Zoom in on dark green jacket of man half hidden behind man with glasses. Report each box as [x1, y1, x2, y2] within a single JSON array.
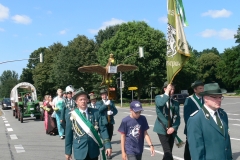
[[183, 94, 201, 135]]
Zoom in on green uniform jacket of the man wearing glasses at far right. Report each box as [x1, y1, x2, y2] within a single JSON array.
[[187, 106, 232, 160]]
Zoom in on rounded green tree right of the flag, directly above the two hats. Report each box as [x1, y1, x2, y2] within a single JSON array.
[[196, 53, 221, 84]]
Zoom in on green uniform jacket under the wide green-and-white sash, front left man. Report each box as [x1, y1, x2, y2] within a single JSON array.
[[65, 108, 111, 160]]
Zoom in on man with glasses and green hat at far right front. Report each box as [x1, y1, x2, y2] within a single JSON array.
[[187, 83, 232, 160]]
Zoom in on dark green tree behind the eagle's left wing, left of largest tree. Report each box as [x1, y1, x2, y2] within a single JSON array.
[[51, 35, 97, 91]]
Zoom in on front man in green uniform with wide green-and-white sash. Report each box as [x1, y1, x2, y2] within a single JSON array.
[[65, 89, 112, 160]]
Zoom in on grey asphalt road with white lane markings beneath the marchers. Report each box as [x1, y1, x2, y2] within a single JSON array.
[[0, 98, 240, 160]]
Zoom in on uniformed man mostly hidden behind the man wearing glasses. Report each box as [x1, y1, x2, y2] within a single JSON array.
[[183, 80, 204, 160]]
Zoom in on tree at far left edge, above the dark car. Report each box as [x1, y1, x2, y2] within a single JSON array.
[[0, 70, 18, 97]]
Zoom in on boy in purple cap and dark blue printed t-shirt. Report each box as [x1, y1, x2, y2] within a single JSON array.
[[118, 101, 155, 160]]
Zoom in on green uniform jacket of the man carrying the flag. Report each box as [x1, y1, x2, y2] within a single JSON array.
[[153, 94, 180, 136]]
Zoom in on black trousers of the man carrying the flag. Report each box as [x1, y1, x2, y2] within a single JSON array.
[[158, 134, 174, 160]]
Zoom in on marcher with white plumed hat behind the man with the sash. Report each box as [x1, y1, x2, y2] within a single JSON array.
[[61, 85, 76, 128]]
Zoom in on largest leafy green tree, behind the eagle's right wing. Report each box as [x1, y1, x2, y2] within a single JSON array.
[[97, 21, 167, 99]]
